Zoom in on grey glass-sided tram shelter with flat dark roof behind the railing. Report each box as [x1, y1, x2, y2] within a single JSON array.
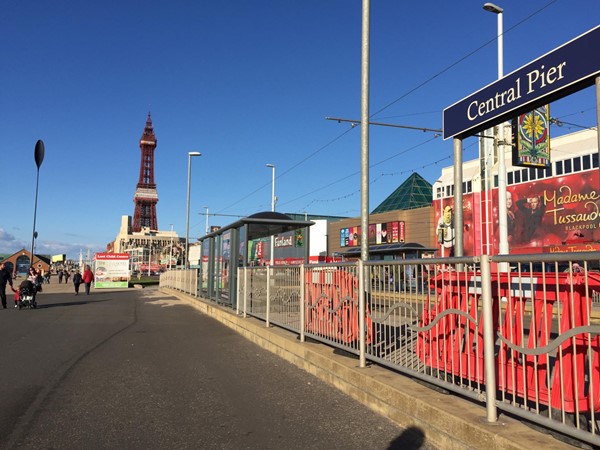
[[198, 211, 314, 308]]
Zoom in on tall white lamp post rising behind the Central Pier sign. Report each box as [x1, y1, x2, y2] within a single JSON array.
[[483, 3, 509, 272]]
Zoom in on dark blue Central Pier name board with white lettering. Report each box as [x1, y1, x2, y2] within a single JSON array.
[[443, 25, 600, 139]]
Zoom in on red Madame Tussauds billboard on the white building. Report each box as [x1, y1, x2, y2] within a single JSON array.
[[434, 170, 600, 256]]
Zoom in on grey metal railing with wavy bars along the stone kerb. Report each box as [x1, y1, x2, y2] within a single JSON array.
[[161, 252, 600, 445]]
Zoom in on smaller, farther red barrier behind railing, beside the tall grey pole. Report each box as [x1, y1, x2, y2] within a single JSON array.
[[304, 268, 373, 344]]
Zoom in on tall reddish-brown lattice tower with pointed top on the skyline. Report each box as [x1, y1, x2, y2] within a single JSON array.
[[131, 113, 158, 232]]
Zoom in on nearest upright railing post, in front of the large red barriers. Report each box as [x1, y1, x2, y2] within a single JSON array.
[[480, 255, 498, 422]]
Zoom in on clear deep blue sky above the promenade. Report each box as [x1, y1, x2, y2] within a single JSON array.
[[0, 0, 600, 258]]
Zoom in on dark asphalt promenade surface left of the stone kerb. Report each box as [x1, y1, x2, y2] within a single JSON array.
[[0, 287, 432, 450]]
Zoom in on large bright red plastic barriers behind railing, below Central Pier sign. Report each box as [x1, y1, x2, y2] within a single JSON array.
[[417, 271, 600, 412]]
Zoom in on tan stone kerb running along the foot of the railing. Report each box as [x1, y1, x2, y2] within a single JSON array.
[[162, 288, 589, 450]]
